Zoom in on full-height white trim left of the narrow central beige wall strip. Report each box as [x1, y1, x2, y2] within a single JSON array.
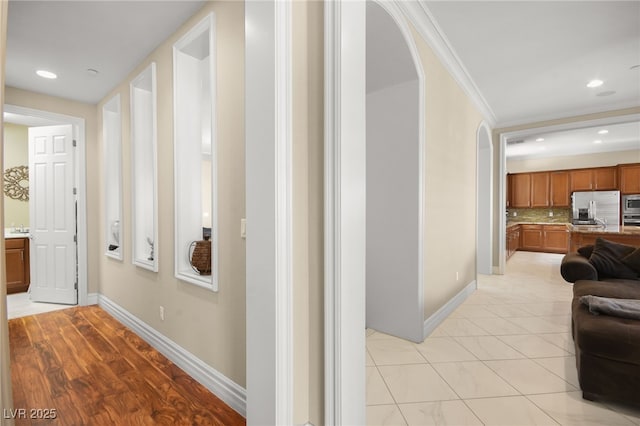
[[245, 0, 294, 425]]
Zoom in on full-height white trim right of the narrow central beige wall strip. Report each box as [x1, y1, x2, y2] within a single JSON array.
[[324, 0, 366, 426]]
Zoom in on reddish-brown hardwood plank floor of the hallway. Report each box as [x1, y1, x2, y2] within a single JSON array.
[[4, 306, 246, 426]]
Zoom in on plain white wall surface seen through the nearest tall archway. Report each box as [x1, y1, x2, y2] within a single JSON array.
[[366, 80, 423, 341]]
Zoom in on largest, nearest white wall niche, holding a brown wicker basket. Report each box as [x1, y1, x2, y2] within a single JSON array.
[[173, 14, 219, 291]]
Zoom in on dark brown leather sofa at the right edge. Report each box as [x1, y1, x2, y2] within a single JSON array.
[[560, 243, 640, 406]]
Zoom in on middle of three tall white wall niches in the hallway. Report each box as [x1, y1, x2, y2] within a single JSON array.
[[130, 62, 158, 272]]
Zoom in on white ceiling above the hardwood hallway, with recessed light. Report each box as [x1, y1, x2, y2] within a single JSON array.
[[5, 0, 203, 104]]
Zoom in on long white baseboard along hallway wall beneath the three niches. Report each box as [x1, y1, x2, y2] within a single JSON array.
[[97, 294, 247, 417]]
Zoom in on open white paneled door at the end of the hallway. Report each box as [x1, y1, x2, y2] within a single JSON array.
[[29, 125, 78, 305]]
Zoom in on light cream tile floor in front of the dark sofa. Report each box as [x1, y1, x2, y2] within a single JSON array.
[[366, 252, 640, 426]]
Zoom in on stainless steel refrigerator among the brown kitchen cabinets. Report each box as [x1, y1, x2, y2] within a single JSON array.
[[571, 191, 620, 226]]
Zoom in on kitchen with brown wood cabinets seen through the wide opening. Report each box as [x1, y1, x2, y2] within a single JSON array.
[[506, 122, 640, 259]]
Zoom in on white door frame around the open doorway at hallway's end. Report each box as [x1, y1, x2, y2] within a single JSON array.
[[4, 104, 89, 306]]
